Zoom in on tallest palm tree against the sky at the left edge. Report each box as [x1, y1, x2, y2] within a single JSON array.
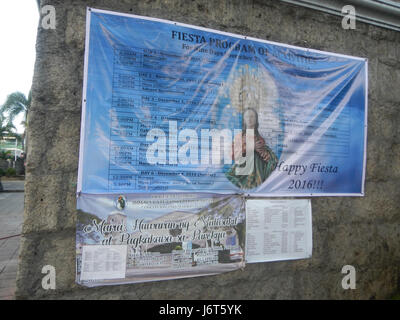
[[0, 91, 32, 151]]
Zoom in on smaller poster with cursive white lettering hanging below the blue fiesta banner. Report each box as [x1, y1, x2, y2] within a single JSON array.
[[76, 194, 246, 286]]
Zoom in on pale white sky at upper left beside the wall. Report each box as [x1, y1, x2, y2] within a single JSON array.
[[0, 0, 39, 133]]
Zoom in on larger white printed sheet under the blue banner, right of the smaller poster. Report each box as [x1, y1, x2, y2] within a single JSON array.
[[246, 199, 312, 263]]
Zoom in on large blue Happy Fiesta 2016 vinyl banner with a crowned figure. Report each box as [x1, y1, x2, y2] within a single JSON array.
[[78, 9, 367, 196]]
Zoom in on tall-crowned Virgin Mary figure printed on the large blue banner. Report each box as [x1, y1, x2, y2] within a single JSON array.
[[225, 68, 278, 189]]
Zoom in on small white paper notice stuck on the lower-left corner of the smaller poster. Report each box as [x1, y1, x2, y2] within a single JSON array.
[[81, 245, 127, 280]]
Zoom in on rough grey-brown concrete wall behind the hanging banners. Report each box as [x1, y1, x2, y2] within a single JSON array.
[[17, 0, 400, 299]]
